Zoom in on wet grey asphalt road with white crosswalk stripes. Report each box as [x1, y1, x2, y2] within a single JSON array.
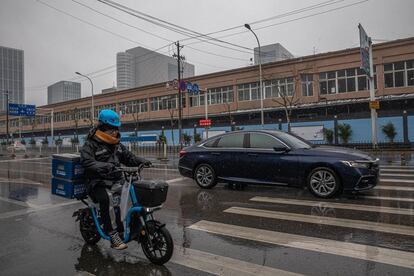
[[0, 158, 414, 275]]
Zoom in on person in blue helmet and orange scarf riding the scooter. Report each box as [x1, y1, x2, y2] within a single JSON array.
[[80, 110, 151, 250]]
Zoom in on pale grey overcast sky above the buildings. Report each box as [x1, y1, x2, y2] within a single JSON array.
[[0, 0, 414, 105]]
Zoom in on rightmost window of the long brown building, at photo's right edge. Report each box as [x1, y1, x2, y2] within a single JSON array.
[[384, 60, 414, 88]]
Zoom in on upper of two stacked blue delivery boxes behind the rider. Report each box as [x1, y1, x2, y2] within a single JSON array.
[[52, 153, 83, 179]]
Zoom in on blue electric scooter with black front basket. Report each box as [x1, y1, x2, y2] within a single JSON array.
[[73, 165, 174, 265]]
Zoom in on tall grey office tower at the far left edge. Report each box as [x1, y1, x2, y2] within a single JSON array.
[[0, 46, 24, 112]]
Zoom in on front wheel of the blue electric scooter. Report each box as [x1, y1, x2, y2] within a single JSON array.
[[141, 221, 174, 265]]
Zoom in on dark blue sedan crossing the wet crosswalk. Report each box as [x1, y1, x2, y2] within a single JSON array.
[[178, 130, 379, 198]]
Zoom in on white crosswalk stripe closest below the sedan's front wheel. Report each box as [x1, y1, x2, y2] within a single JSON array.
[[250, 196, 414, 216]]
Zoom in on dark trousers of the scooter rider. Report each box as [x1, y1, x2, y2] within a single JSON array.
[[89, 186, 124, 235]]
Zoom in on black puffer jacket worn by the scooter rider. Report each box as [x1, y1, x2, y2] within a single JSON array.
[[80, 128, 147, 191]]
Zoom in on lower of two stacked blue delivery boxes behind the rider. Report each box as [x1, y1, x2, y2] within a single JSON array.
[[52, 177, 86, 198]]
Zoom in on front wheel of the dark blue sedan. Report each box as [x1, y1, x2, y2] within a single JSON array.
[[308, 167, 341, 198]]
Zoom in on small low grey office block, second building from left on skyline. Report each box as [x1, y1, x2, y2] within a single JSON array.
[[47, 81, 81, 104]]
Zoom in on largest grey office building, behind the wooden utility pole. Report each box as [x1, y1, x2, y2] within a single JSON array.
[[116, 47, 194, 90]]
